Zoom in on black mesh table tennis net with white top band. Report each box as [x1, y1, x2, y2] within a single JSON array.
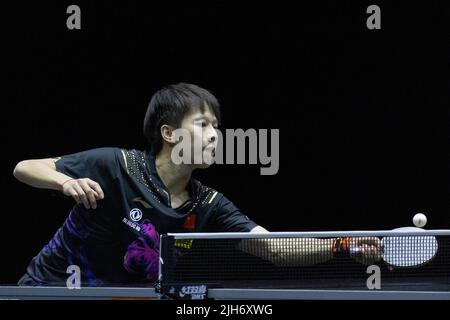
[[160, 232, 450, 291]]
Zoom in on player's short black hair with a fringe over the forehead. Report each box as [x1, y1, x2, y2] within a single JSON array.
[[144, 83, 220, 155]]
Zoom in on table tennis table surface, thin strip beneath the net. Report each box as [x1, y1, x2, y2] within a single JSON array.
[[0, 286, 450, 300]]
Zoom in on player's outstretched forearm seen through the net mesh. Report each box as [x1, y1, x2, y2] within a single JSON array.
[[239, 238, 333, 266]]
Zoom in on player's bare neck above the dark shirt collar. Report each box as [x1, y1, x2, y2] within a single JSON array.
[[155, 150, 192, 196]]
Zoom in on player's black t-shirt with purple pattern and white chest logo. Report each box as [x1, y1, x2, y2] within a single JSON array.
[[22, 148, 257, 286]]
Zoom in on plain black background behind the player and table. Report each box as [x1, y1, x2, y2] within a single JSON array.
[[0, 0, 450, 283]]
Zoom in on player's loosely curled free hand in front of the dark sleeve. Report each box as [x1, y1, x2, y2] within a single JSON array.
[[62, 178, 104, 209]]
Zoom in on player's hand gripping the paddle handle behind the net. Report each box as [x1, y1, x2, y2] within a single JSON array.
[[350, 237, 383, 265]]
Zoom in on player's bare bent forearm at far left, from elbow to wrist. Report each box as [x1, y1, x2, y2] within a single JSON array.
[[14, 159, 71, 191]]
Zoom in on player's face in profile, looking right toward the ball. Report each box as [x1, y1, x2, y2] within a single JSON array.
[[181, 105, 218, 168]]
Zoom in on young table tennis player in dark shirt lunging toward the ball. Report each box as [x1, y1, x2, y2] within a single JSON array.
[[14, 83, 379, 286]]
